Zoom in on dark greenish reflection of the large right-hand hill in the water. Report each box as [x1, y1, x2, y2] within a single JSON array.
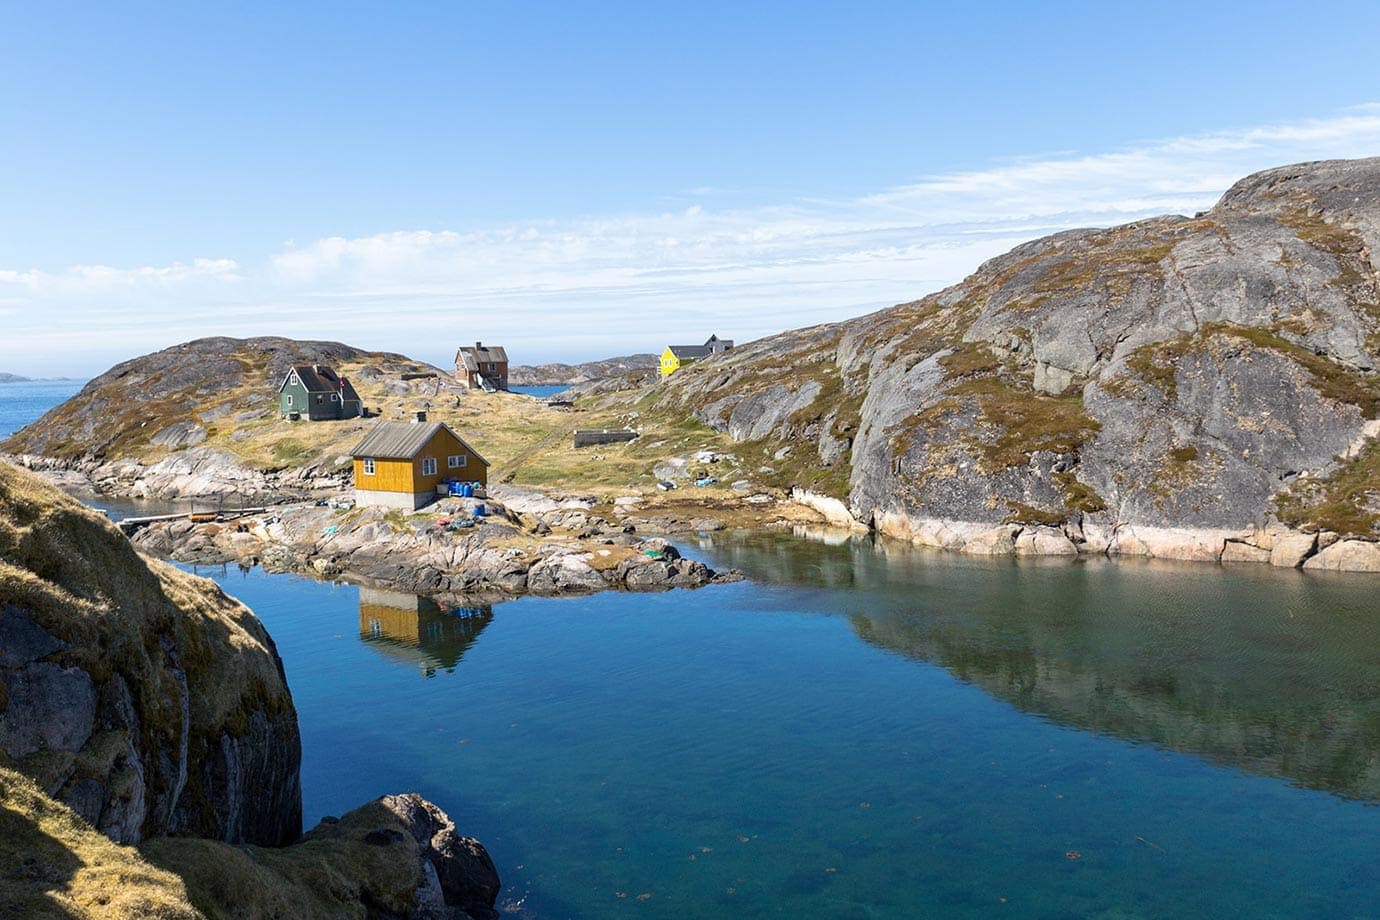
[[713, 537, 1380, 801]]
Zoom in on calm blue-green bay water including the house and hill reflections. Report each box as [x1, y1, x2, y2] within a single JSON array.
[[197, 537, 1380, 917]]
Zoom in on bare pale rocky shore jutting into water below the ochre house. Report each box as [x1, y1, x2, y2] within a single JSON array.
[[131, 488, 741, 597]]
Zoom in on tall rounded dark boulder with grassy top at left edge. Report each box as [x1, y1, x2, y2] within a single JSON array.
[[0, 463, 301, 846]]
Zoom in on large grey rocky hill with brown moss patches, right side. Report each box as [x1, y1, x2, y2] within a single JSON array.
[[642, 159, 1380, 564]]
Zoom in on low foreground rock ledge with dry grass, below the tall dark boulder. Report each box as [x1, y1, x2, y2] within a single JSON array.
[[0, 767, 500, 920]]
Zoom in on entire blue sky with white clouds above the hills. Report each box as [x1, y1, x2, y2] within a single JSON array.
[[0, 1, 1380, 375]]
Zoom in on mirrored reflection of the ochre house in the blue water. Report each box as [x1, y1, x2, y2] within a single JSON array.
[[359, 588, 494, 677]]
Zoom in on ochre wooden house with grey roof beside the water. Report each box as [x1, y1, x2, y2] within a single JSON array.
[[351, 422, 489, 510]]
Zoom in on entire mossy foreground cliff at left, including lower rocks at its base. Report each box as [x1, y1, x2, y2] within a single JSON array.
[[0, 462, 498, 920]]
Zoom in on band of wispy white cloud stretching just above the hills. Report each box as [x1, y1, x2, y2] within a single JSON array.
[[0, 105, 1380, 372]]
